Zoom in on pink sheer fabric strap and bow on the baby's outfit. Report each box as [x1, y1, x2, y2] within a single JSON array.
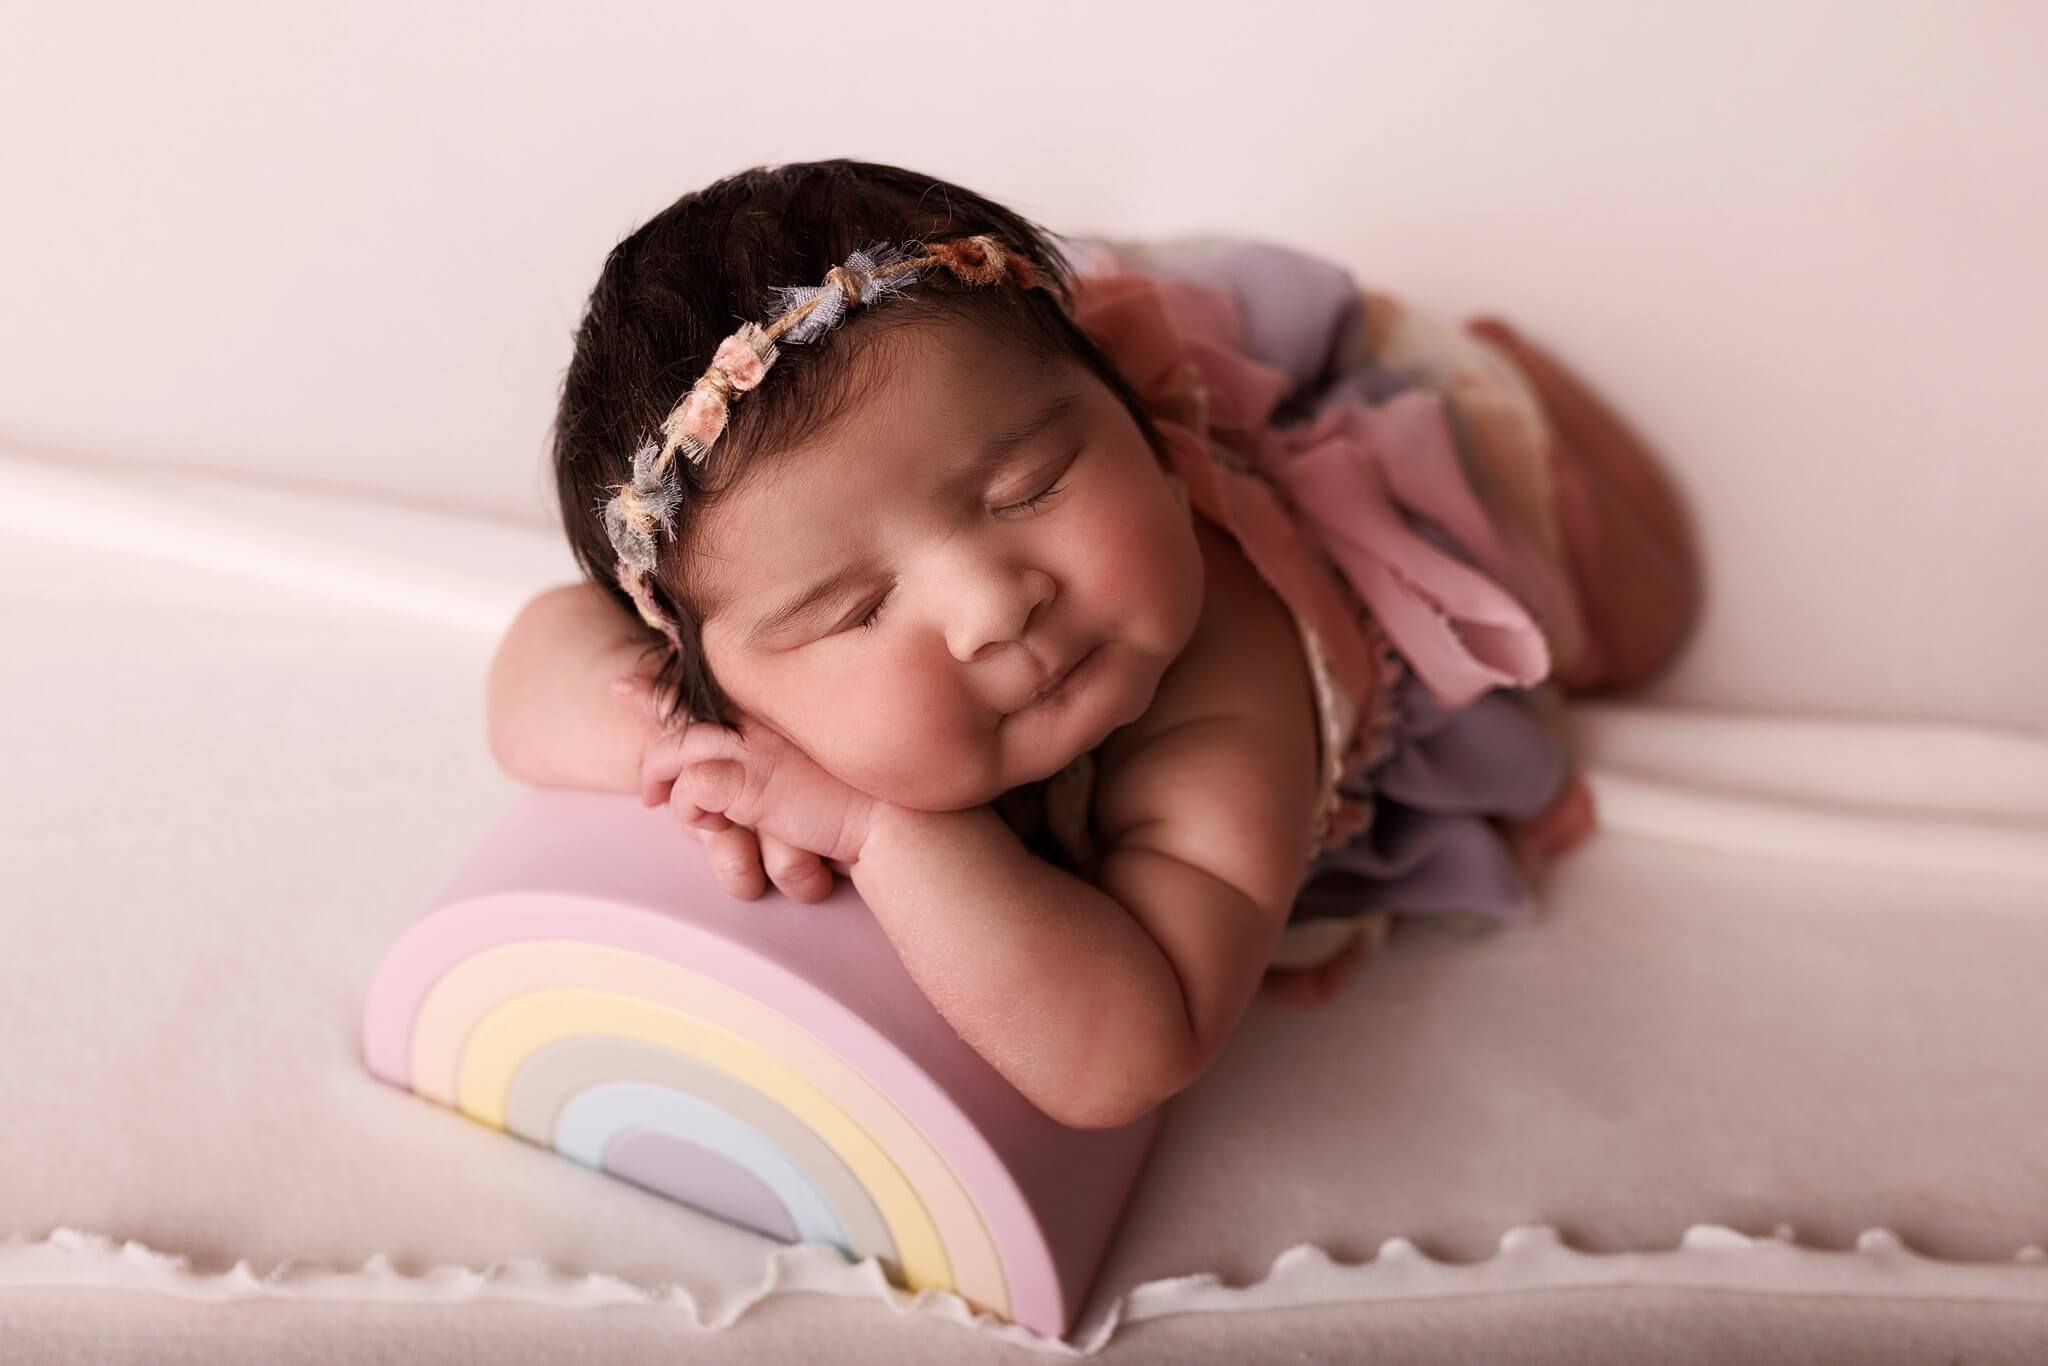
[[1075, 270, 1571, 709]]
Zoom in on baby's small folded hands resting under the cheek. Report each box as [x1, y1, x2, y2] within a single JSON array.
[[614, 674, 872, 901]]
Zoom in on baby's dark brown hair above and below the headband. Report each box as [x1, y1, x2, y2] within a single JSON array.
[[553, 160, 1161, 725]]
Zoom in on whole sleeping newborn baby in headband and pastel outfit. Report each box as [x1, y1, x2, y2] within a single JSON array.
[[489, 162, 1696, 1126]]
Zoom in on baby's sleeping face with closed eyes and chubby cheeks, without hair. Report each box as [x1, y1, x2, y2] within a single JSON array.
[[694, 319, 1202, 811]]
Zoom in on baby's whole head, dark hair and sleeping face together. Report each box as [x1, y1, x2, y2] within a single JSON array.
[[555, 162, 1202, 811]]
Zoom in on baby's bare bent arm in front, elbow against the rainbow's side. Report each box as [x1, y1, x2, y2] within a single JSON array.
[[852, 518, 1317, 1128]]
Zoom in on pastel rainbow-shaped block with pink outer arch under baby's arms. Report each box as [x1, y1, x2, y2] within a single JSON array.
[[362, 788, 1159, 1335]]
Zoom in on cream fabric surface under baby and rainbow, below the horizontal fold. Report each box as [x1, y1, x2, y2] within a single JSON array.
[[0, 457, 2048, 1360]]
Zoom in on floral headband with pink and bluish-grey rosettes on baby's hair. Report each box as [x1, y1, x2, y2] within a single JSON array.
[[604, 233, 1040, 651]]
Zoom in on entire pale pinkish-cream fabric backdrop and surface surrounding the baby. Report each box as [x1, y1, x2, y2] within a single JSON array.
[[0, 0, 2048, 1366]]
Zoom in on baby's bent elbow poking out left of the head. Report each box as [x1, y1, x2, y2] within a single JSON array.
[[485, 584, 657, 793]]
